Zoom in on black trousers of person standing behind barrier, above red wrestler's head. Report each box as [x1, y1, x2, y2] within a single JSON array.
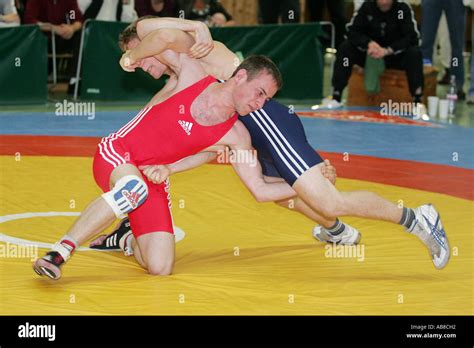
[[258, 0, 301, 24]]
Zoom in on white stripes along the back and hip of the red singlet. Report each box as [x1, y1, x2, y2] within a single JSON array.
[[99, 106, 152, 168]]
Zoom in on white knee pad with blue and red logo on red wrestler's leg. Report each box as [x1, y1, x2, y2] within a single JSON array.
[[102, 175, 148, 219]]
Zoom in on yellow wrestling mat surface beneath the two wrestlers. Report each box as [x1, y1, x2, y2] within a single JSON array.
[[0, 156, 474, 315]]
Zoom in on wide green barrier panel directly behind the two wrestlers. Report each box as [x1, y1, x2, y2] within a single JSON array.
[[80, 21, 323, 101]]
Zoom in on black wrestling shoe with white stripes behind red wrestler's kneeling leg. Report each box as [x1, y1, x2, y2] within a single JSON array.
[[89, 219, 133, 256]]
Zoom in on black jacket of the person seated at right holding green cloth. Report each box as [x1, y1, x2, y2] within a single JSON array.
[[346, 0, 420, 54]]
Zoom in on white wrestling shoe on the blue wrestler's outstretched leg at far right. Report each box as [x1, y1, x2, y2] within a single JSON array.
[[407, 204, 450, 269]]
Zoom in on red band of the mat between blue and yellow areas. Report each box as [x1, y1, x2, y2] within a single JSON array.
[[0, 135, 474, 200]]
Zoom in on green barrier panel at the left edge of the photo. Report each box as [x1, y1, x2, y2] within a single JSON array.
[[0, 25, 48, 105]]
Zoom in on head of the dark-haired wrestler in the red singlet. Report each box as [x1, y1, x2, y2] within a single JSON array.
[[232, 56, 283, 115]]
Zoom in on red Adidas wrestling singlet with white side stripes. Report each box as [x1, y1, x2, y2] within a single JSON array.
[[93, 76, 237, 237]]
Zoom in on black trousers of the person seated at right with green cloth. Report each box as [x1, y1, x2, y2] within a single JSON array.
[[332, 40, 424, 96]]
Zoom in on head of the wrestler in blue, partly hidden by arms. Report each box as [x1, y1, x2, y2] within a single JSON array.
[[119, 16, 168, 79]]
